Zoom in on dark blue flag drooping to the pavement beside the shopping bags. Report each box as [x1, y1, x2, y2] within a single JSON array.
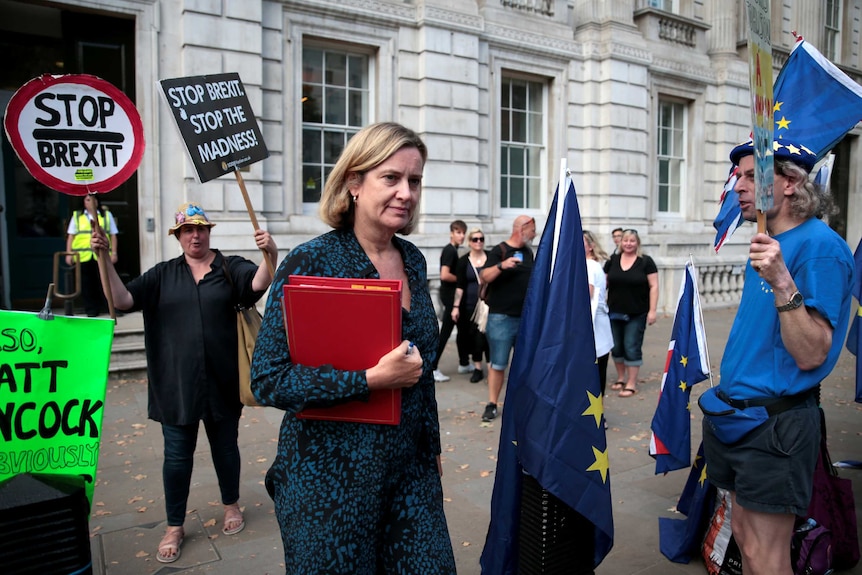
[[658, 443, 716, 563]]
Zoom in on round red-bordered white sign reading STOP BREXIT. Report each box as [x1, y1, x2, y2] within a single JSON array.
[[4, 74, 144, 196]]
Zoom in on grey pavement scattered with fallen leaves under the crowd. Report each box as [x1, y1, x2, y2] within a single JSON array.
[[90, 309, 862, 575]]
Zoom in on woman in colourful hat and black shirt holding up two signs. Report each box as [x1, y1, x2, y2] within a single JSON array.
[[91, 204, 278, 563]]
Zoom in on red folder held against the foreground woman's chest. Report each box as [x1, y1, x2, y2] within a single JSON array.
[[283, 276, 401, 425]]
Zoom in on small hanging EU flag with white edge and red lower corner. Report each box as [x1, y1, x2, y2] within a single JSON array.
[[650, 262, 709, 474]]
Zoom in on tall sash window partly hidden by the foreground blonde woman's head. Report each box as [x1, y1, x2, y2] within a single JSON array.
[[302, 46, 369, 203]]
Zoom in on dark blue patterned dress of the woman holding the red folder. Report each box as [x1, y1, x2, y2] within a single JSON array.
[[251, 230, 455, 575]]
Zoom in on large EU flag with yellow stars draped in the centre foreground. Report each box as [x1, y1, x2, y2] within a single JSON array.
[[481, 174, 614, 575]]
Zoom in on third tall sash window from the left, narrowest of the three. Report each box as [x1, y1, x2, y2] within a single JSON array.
[[656, 100, 686, 214]]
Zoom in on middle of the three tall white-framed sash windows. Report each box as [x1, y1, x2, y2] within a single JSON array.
[[500, 77, 545, 209]]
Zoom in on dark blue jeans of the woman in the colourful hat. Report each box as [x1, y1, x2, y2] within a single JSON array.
[[162, 418, 240, 527]]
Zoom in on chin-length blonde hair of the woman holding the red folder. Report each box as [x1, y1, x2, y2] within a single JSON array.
[[320, 122, 428, 235]]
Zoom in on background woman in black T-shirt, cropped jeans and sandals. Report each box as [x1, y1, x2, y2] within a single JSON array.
[[605, 230, 658, 397]]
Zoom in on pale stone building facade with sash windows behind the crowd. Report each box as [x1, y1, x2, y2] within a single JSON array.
[[0, 0, 862, 313]]
